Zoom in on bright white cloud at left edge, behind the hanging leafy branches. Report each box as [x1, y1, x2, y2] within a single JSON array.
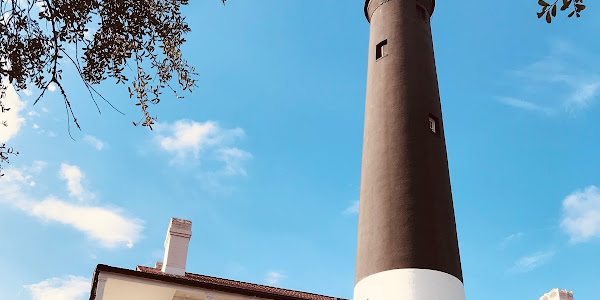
[[0, 80, 25, 143]]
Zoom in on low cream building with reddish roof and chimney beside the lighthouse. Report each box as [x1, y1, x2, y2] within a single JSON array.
[[90, 218, 346, 300]]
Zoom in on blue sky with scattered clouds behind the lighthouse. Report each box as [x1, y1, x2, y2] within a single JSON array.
[[0, 0, 600, 300]]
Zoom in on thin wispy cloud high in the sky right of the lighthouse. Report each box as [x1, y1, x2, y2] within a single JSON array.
[[500, 41, 600, 115]]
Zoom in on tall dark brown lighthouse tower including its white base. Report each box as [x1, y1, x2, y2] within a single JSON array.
[[354, 0, 465, 300]]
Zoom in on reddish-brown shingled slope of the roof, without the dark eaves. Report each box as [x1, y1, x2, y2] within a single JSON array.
[[137, 266, 347, 300]]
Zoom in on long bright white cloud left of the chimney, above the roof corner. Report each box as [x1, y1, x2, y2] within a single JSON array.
[[0, 164, 143, 248]]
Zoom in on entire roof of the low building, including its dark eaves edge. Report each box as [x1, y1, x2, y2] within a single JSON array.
[[90, 265, 347, 300]]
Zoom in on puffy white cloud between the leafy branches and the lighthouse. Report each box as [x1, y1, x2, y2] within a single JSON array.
[[156, 120, 252, 176]]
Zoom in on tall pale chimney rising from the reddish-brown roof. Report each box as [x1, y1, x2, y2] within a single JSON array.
[[161, 218, 192, 276]]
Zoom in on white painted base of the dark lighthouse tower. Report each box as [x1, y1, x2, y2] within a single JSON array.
[[353, 269, 465, 300]]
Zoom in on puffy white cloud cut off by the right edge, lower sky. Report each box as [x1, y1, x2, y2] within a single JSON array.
[[560, 185, 600, 243]]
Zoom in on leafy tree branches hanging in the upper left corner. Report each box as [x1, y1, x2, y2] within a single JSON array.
[[0, 0, 225, 178]]
